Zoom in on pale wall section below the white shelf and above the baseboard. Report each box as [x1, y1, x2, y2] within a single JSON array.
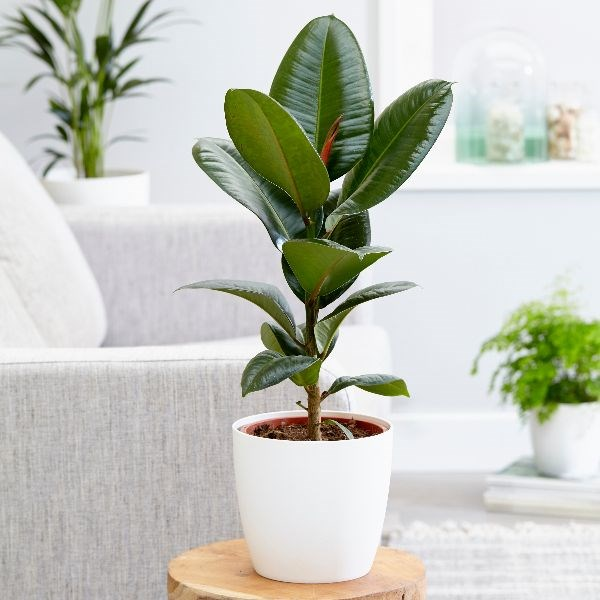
[[371, 185, 600, 412]]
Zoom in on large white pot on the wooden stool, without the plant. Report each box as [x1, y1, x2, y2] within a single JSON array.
[[233, 411, 393, 583]]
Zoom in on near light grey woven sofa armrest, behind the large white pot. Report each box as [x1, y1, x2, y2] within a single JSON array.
[[0, 340, 348, 600]]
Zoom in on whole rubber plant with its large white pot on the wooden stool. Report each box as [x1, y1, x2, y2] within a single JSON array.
[[182, 16, 452, 583]]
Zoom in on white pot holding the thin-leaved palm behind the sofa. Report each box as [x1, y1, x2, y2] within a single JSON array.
[[42, 169, 150, 206]]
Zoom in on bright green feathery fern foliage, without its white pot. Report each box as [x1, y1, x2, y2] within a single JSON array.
[[472, 289, 600, 422]]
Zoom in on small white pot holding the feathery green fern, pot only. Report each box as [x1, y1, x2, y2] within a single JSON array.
[[530, 402, 600, 479]]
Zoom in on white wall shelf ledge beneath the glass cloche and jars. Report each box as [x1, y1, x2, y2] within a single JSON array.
[[401, 157, 600, 192]]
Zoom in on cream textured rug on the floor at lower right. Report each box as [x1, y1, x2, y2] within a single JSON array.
[[388, 522, 600, 600]]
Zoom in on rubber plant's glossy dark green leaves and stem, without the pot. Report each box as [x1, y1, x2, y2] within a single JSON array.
[[180, 16, 452, 440]]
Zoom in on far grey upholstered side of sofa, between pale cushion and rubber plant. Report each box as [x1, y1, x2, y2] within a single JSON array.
[[63, 201, 364, 346]]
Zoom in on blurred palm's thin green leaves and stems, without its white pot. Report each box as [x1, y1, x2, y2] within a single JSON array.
[[0, 0, 172, 177]]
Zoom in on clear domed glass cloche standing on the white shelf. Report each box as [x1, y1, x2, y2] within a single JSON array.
[[455, 30, 547, 163]]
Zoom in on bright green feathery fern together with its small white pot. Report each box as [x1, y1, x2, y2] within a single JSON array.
[[473, 289, 600, 479]]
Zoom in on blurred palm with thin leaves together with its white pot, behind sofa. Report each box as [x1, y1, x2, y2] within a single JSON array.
[[0, 0, 170, 205]]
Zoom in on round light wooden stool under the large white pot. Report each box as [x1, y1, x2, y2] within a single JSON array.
[[167, 540, 425, 600]]
